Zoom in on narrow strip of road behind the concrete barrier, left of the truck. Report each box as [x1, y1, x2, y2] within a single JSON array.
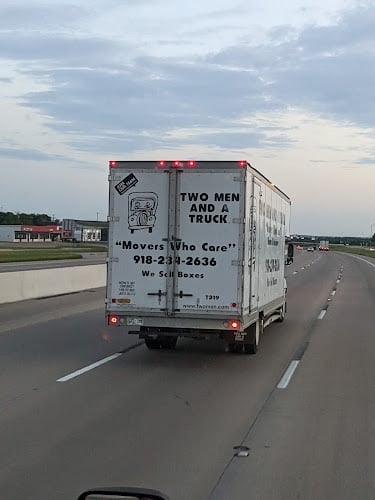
[[0, 252, 107, 273]]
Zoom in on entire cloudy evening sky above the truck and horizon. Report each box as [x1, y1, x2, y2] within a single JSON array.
[[0, 0, 375, 236]]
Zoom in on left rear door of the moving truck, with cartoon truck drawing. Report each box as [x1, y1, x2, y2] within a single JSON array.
[[107, 166, 169, 312]]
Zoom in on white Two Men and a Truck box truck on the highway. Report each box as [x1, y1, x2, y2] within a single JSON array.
[[106, 161, 290, 353]]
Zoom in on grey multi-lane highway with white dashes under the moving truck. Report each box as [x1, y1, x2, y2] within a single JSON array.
[[0, 251, 375, 500]]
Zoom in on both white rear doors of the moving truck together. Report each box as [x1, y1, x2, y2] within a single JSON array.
[[107, 162, 245, 316]]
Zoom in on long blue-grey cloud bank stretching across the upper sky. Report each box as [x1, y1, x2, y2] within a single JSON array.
[[0, 2, 375, 152]]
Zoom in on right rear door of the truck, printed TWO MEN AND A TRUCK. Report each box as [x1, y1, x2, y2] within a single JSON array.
[[172, 170, 244, 315]]
